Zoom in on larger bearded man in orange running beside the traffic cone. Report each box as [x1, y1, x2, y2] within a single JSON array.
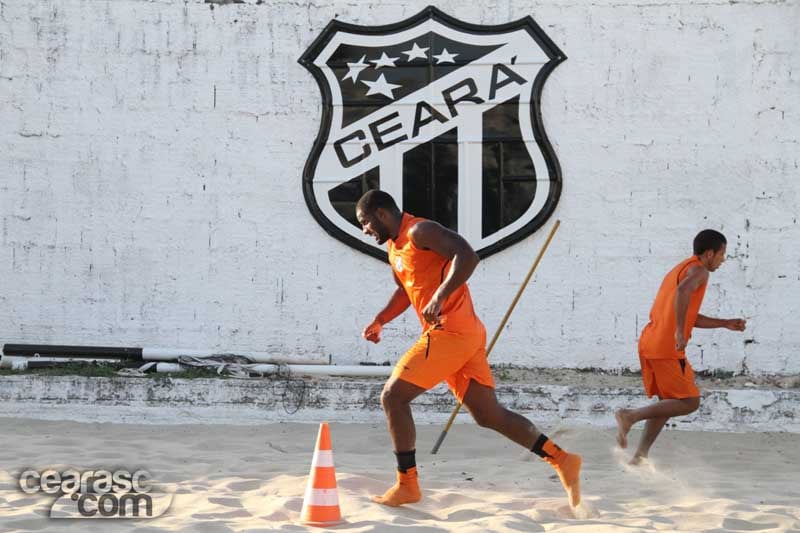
[[356, 190, 581, 507]]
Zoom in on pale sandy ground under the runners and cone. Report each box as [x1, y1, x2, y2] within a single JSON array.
[[0, 419, 800, 533]]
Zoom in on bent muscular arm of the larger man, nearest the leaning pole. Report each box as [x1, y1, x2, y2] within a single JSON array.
[[409, 221, 480, 324]]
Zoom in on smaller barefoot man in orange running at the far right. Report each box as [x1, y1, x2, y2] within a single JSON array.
[[615, 229, 745, 464]]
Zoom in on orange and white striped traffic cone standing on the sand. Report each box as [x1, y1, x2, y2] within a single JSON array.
[[300, 422, 342, 527]]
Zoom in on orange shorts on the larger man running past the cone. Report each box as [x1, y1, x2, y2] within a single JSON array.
[[392, 328, 494, 402]]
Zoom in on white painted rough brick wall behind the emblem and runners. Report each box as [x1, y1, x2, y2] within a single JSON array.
[[0, 0, 800, 373]]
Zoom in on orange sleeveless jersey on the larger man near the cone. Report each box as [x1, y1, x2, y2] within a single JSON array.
[[388, 213, 483, 332]]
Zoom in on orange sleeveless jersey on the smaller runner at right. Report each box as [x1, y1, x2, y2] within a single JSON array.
[[639, 256, 708, 359]]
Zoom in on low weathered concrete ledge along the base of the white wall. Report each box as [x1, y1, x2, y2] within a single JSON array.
[[0, 375, 800, 433]]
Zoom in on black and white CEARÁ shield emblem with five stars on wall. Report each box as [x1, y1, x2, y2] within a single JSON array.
[[300, 7, 566, 259]]
